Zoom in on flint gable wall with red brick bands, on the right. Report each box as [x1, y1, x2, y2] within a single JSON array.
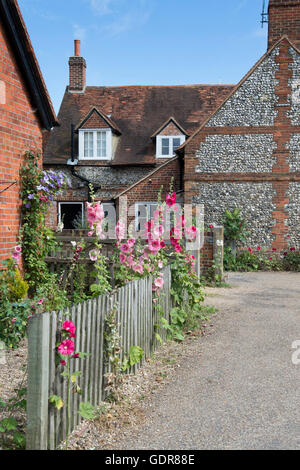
[[185, 38, 300, 250]]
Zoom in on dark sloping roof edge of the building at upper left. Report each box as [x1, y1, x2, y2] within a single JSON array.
[[0, 0, 59, 130]]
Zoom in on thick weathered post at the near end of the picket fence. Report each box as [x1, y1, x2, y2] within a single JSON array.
[[26, 313, 50, 450]]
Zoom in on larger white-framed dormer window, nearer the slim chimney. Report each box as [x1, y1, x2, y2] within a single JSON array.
[[79, 129, 112, 160]]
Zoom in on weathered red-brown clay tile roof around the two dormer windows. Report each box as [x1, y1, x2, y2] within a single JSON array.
[[44, 85, 233, 165]]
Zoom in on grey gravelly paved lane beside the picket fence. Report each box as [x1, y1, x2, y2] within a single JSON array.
[[110, 273, 300, 450]]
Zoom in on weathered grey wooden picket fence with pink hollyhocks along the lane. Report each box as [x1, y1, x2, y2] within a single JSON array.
[[26, 266, 171, 450]]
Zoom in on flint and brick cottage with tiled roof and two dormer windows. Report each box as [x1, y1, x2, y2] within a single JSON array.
[[44, 0, 300, 250]]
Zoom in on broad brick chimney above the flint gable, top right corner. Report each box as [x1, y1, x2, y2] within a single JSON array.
[[268, 0, 300, 48]]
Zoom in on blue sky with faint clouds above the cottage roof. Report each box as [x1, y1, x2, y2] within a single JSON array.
[[19, 0, 267, 112]]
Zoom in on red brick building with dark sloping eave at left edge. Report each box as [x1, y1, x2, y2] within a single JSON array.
[[0, 0, 58, 260]]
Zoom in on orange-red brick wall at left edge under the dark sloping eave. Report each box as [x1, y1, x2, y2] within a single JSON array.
[[0, 20, 42, 260]]
